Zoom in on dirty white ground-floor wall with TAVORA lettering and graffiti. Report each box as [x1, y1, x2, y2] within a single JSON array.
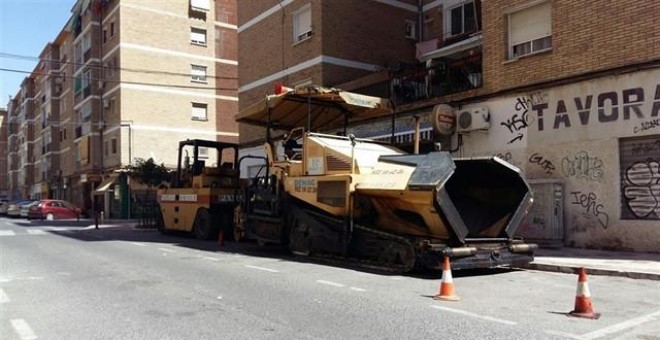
[[461, 70, 660, 252]]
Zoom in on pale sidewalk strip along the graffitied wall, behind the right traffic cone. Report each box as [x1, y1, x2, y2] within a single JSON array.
[[523, 248, 660, 281]]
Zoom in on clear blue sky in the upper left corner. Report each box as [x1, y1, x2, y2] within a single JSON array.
[[0, 0, 75, 108]]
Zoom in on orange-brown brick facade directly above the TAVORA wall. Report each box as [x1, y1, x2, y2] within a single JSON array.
[[483, 0, 660, 92]]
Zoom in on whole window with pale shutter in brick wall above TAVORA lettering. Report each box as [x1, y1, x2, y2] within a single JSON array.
[[508, 2, 552, 59]]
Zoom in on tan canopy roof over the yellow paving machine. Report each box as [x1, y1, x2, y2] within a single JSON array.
[[236, 86, 391, 132]]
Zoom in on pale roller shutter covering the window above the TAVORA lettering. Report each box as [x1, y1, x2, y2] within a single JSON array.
[[509, 2, 552, 46]]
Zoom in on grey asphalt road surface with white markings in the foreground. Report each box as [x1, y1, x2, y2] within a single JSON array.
[[0, 217, 660, 340]]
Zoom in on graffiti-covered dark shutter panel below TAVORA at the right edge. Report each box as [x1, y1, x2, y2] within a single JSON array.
[[619, 135, 660, 220]]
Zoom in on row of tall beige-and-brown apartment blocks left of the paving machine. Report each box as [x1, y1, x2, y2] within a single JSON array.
[[5, 0, 238, 217]]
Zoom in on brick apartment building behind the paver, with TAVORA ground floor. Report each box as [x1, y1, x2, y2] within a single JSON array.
[[238, 0, 660, 251]]
